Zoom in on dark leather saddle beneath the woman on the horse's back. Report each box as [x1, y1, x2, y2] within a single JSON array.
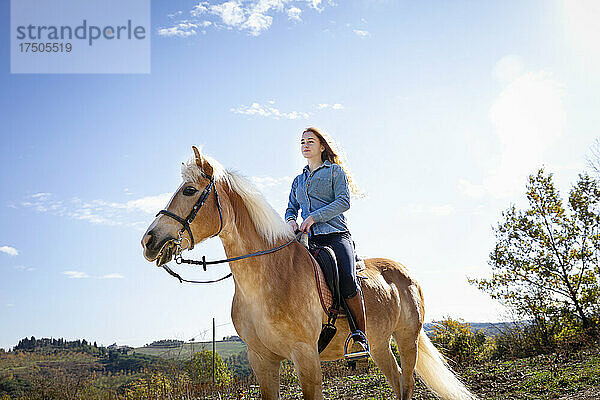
[[307, 239, 366, 353]]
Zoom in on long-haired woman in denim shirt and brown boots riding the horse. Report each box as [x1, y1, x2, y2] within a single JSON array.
[[285, 128, 368, 352]]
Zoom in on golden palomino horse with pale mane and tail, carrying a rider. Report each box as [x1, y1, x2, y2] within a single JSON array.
[[142, 147, 476, 400]]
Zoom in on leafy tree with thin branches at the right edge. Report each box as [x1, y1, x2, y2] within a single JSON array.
[[470, 168, 600, 342]]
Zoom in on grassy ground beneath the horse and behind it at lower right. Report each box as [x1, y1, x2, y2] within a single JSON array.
[[215, 349, 600, 400]]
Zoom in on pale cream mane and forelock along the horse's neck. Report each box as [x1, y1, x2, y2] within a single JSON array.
[[181, 155, 294, 245]]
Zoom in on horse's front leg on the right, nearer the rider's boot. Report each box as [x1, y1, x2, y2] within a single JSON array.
[[290, 343, 323, 400]]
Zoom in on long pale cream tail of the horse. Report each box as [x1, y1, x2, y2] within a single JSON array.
[[416, 330, 477, 400]]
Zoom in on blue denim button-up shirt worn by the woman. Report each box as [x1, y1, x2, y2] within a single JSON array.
[[285, 160, 350, 235]]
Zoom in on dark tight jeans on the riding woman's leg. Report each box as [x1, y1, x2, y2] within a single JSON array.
[[308, 232, 360, 299]]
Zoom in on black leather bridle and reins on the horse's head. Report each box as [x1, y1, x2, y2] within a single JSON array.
[[156, 176, 303, 283]]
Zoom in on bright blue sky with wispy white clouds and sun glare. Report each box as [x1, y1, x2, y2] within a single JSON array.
[[0, 0, 600, 349]]
